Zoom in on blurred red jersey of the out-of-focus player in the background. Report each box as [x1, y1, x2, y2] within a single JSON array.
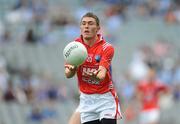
[[138, 81, 167, 110]]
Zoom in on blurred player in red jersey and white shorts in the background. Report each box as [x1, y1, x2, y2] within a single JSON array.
[[137, 68, 168, 124]]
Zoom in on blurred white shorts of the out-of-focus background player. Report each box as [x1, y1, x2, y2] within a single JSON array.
[[140, 109, 160, 124]]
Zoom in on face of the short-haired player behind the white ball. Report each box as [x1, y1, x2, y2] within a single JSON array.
[[80, 17, 100, 40]]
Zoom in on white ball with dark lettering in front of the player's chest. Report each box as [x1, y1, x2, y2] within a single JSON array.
[[63, 41, 88, 66]]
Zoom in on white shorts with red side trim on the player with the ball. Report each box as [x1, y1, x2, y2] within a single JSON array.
[[76, 92, 121, 123]]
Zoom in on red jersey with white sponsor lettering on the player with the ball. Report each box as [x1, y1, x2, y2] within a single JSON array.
[[75, 35, 114, 94]]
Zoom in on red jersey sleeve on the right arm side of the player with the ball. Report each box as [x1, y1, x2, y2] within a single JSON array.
[[99, 45, 114, 69]]
